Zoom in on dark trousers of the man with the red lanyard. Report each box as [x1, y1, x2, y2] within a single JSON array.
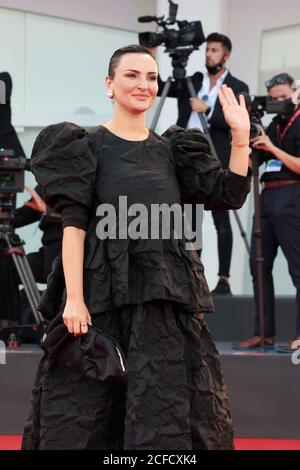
[[250, 183, 300, 337]]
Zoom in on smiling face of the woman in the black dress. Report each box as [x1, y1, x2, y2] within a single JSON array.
[[106, 53, 158, 114]]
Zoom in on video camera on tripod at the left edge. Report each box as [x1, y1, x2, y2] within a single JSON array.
[[0, 149, 43, 344]]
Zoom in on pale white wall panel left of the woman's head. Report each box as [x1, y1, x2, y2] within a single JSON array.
[[0, 8, 137, 128]]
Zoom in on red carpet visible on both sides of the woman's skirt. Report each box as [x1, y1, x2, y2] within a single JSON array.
[[0, 436, 300, 450]]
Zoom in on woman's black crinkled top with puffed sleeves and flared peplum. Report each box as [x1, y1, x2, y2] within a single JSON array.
[[31, 123, 250, 314]]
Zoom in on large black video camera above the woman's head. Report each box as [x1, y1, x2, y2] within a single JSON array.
[[138, 0, 205, 53]]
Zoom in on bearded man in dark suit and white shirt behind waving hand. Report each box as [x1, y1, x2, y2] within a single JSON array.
[[151, 33, 249, 295]]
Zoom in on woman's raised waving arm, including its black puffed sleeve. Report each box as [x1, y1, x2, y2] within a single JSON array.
[[163, 85, 250, 210]]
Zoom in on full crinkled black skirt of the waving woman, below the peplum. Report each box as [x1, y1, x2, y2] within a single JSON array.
[[22, 301, 233, 450]]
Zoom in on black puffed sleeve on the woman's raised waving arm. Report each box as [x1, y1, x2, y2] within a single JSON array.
[[163, 126, 251, 210]]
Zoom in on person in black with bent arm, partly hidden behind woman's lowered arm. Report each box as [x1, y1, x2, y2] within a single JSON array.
[[14, 185, 62, 284]]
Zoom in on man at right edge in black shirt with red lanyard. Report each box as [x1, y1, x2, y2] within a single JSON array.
[[233, 73, 300, 352]]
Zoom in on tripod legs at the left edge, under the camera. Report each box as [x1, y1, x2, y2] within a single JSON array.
[[0, 223, 43, 341]]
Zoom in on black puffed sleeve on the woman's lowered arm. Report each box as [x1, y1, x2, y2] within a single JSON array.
[[31, 122, 97, 229]]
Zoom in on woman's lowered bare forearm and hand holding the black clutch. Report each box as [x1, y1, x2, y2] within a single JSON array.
[[62, 226, 91, 336]]
